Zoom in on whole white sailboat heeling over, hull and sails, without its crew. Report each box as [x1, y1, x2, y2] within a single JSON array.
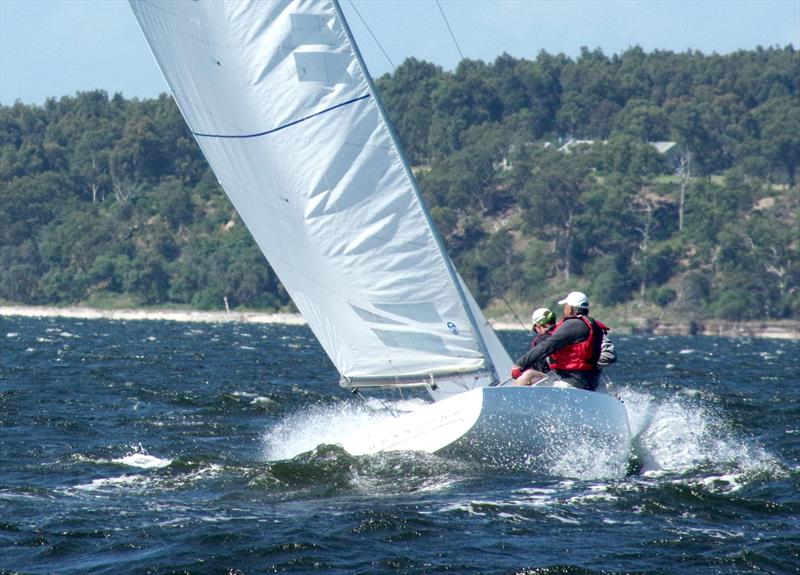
[[130, 0, 630, 474]]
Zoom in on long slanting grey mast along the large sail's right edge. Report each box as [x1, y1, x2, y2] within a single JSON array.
[[331, 0, 500, 388]]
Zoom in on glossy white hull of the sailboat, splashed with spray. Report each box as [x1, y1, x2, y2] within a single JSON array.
[[343, 386, 631, 471]]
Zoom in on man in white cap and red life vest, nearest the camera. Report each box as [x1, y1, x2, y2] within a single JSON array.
[[511, 292, 616, 391]]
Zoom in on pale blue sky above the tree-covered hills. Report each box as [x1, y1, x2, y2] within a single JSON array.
[[0, 0, 800, 105]]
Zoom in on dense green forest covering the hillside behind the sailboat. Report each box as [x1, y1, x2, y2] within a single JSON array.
[[0, 47, 800, 319]]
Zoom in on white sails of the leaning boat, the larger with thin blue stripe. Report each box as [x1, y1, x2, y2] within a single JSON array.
[[130, 0, 510, 385]]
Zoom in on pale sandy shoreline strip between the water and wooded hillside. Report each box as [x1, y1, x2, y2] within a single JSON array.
[[0, 305, 800, 340]]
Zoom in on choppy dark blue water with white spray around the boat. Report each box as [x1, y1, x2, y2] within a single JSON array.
[[0, 318, 800, 575]]
